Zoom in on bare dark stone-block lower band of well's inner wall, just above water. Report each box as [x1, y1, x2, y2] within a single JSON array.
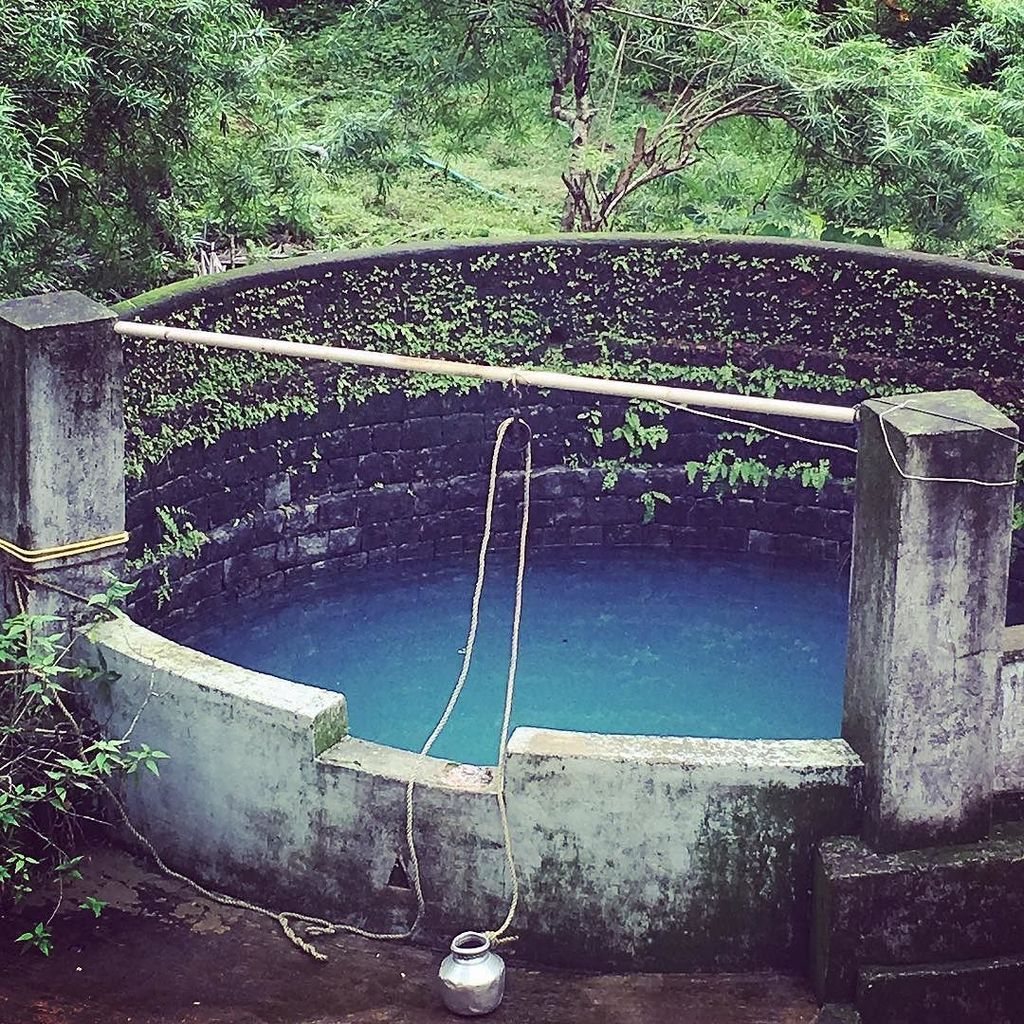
[[128, 387, 853, 627]]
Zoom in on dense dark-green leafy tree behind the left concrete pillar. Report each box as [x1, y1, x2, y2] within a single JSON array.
[[0, 0, 303, 295]]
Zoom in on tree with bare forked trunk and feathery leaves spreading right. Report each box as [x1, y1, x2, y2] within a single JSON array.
[[403, 0, 1016, 245]]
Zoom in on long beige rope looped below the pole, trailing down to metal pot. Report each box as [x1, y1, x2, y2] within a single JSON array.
[[15, 416, 534, 962]]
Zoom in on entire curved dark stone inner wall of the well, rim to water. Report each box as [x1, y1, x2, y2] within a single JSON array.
[[120, 236, 1024, 621]]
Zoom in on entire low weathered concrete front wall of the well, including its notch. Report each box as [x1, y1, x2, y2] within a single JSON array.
[[81, 621, 861, 970]]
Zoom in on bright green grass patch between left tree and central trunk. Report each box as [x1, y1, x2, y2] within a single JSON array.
[[249, 10, 566, 249]]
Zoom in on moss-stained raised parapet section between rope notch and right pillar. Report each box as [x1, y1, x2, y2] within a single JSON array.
[[507, 728, 861, 970]]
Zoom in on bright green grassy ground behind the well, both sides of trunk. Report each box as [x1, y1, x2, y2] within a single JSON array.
[[243, 6, 937, 256]]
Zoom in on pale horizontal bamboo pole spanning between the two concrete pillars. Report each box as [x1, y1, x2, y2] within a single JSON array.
[[114, 321, 857, 423]]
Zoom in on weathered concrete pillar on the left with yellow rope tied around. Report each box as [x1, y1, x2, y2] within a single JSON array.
[[0, 292, 125, 614]]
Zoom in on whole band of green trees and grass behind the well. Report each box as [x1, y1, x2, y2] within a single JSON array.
[[6, 0, 1024, 295]]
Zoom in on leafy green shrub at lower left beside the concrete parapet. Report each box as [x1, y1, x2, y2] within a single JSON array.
[[0, 581, 167, 954]]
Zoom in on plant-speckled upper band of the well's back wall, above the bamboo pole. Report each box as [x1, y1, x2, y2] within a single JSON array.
[[119, 234, 1024, 382]]
